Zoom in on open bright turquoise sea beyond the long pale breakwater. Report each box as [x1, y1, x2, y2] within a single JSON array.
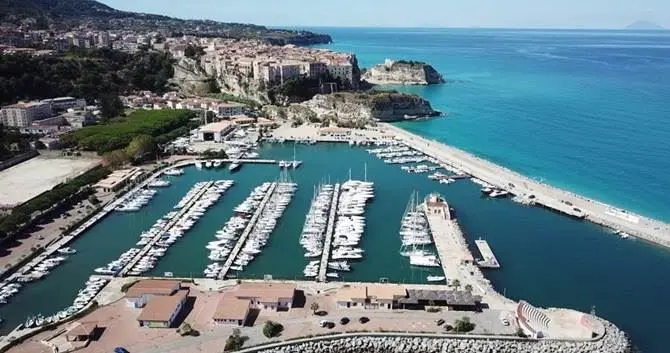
[[315, 28, 670, 221]]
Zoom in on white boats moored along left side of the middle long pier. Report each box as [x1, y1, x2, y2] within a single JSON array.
[[204, 182, 272, 278]]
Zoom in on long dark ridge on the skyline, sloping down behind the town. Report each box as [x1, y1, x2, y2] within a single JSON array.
[[0, 0, 332, 45]]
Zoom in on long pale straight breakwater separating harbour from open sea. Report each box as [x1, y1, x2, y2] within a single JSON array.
[[380, 123, 670, 248]]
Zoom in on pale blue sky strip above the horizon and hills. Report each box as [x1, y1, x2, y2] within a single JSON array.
[[102, 0, 670, 28]]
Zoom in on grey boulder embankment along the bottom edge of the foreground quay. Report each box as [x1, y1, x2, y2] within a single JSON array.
[[245, 320, 631, 353]]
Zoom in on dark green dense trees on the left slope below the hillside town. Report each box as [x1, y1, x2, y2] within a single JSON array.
[[0, 49, 173, 104]]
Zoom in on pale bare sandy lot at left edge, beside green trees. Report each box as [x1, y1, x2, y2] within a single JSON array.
[[0, 156, 100, 207]]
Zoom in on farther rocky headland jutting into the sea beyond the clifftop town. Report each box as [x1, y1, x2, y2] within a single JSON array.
[[363, 59, 445, 85]]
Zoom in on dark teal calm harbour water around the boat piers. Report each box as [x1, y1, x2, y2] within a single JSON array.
[[0, 143, 670, 353]]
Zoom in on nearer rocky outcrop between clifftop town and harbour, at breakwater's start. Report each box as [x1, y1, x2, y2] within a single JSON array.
[[264, 91, 441, 127]]
